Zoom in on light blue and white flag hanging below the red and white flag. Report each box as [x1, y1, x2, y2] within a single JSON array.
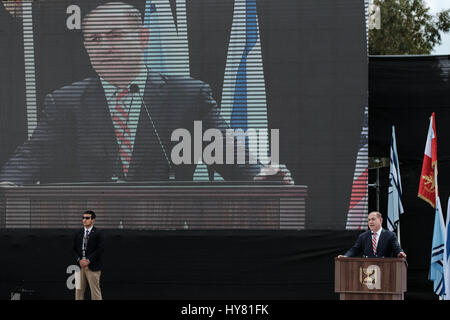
[[429, 196, 445, 297]]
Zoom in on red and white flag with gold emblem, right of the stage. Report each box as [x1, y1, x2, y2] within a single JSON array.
[[417, 112, 439, 208]]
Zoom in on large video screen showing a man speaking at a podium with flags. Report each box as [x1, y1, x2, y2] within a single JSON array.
[[0, 0, 368, 230]]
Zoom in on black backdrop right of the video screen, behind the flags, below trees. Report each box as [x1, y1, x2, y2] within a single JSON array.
[[369, 56, 450, 284]]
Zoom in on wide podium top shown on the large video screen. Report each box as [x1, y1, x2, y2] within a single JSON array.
[[0, 183, 307, 230]]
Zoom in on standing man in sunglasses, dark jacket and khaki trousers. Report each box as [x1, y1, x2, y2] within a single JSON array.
[[73, 210, 104, 300]]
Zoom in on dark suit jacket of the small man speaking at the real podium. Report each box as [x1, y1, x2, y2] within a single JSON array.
[[345, 229, 403, 258]]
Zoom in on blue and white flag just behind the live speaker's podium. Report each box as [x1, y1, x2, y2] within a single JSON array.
[[387, 126, 403, 243]]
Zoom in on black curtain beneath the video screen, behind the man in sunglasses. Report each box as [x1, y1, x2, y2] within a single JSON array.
[[0, 230, 435, 300]]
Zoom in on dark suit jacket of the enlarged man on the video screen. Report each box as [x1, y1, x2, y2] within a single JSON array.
[[0, 72, 260, 185]]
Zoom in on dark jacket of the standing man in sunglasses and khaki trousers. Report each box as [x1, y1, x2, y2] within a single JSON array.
[[72, 227, 105, 271]]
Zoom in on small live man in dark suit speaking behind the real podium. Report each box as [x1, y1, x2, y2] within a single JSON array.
[[338, 211, 406, 259]]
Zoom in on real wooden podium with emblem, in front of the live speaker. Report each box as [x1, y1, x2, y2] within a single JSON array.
[[334, 258, 406, 300]]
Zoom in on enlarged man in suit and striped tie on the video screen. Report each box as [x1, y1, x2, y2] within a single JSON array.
[[0, 2, 293, 185]]
